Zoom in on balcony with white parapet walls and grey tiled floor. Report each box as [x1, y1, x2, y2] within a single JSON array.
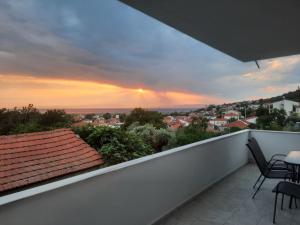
[[0, 130, 300, 225]]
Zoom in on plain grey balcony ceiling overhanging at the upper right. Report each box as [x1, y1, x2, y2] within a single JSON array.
[[121, 0, 300, 62]]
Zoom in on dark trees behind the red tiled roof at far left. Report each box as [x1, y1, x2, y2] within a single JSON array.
[[0, 104, 73, 135]]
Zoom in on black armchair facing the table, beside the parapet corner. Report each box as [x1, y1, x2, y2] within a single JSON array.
[[246, 138, 292, 199]]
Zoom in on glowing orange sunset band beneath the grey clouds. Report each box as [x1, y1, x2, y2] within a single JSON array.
[[0, 75, 224, 108]]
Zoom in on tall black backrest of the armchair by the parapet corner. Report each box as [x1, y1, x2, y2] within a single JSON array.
[[246, 138, 268, 174]]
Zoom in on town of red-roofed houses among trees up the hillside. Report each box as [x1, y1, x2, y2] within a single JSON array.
[[72, 96, 300, 133]]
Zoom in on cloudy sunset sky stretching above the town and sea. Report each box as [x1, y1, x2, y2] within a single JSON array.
[[0, 0, 300, 108]]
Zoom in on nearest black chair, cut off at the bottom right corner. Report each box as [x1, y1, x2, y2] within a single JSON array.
[[273, 181, 300, 223]]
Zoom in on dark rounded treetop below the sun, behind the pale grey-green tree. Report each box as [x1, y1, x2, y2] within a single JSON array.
[[124, 108, 166, 128]]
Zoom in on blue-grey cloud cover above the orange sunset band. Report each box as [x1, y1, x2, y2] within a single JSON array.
[[0, 0, 300, 107]]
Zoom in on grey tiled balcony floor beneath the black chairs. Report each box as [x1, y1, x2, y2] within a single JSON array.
[[159, 164, 300, 225]]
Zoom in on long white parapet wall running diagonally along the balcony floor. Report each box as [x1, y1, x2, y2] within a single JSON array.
[[0, 130, 250, 225]]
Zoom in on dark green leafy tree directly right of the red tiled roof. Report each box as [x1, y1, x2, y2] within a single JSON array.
[[74, 126, 154, 165]]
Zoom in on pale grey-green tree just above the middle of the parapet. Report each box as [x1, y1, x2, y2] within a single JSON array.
[[128, 124, 175, 152]]
